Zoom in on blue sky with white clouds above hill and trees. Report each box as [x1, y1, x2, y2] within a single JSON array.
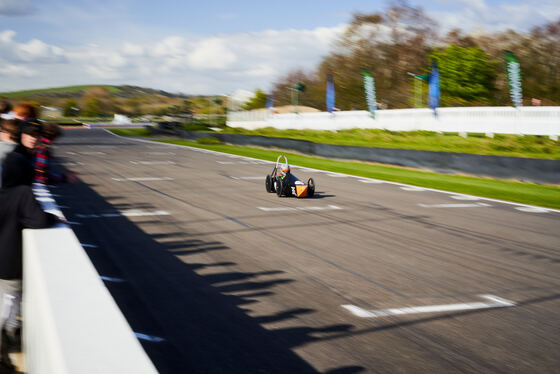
[[0, 0, 560, 95]]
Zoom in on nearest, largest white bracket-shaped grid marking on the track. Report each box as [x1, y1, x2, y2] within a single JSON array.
[[342, 295, 516, 318]]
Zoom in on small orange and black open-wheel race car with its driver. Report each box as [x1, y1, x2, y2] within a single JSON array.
[[265, 155, 315, 197]]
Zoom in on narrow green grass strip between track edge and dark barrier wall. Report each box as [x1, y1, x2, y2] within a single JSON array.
[[151, 137, 560, 209]]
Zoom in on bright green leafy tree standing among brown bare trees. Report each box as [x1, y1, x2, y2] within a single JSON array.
[[430, 44, 498, 106]]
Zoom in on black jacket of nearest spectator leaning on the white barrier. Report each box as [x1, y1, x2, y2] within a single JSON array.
[[0, 186, 56, 279]]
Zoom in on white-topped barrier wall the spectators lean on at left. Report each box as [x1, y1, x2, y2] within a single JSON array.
[[23, 185, 157, 374]]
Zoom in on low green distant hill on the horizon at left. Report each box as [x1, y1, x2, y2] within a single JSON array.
[[0, 85, 191, 100]]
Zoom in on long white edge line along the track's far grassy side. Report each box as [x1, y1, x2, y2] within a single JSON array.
[[103, 129, 560, 213]]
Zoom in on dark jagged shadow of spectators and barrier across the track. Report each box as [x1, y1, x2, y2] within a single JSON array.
[[53, 179, 364, 374]]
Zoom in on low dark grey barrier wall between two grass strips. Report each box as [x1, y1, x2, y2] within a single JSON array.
[[180, 131, 560, 184]]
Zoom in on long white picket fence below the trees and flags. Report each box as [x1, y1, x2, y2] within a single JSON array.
[[227, 106, 560, 140]]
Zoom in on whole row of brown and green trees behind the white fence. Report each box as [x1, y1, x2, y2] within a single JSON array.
[[252, 1, 560, 110]]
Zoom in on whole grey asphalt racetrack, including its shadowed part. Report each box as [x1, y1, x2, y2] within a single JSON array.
[[53, 130, 560, 374]]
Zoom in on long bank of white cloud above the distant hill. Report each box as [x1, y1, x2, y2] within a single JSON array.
[[0, 26, 343, 94]]
